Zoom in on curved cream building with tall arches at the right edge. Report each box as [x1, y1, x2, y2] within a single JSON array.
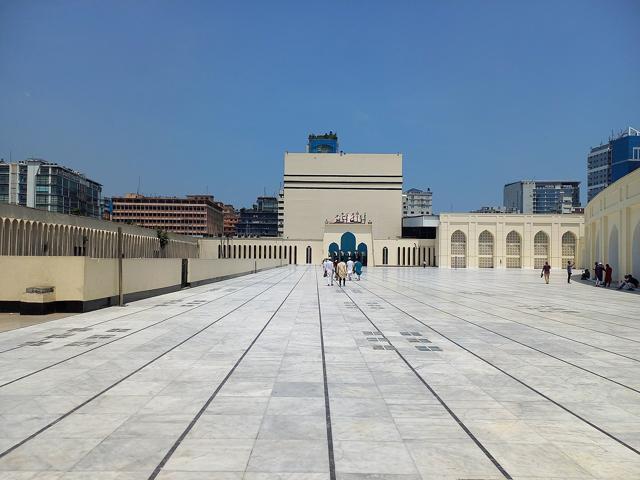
[[584, 169, 640, 280]]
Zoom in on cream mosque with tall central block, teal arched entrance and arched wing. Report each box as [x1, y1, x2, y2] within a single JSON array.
[[201, 132, 584, 268]]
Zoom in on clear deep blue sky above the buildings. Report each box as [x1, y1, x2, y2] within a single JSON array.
[[0, 0, 640, 211]]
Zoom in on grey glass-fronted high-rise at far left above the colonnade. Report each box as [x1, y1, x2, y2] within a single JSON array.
[[0, 158, 102, 218]]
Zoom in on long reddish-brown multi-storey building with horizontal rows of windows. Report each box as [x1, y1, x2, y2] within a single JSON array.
[[111, 193, 223, 237]]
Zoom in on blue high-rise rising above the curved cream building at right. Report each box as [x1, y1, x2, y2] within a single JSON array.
[[587, 127, 640, 202]]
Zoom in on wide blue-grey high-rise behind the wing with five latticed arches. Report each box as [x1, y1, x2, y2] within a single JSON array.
[[503, 180, 580, 213]]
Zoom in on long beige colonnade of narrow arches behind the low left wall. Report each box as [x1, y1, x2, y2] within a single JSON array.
[[0, 218, 198, 258]]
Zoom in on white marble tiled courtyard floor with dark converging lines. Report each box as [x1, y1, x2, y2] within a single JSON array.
[[0, 267, 640, 480]]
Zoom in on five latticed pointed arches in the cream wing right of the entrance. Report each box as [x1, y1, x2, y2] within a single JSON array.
[[450, 230, 578, 268]]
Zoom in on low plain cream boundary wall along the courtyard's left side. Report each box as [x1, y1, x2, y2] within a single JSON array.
[[0, 256, 282, 313]]
